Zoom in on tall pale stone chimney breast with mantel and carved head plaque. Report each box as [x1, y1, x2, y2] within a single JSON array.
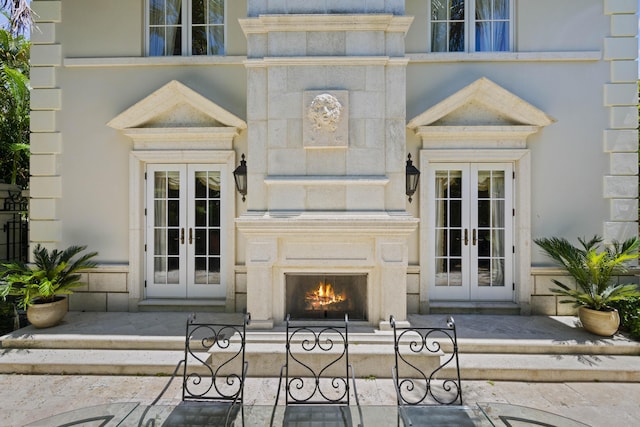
[[237, 2, 417, 328]]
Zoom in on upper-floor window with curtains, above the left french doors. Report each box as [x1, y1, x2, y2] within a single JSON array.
[[145, 0, 226, 56]]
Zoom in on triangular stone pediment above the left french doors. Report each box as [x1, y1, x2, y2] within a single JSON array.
[[107, 80, 247, 131]]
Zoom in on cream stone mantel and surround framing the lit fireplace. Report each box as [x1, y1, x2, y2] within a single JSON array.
[[236, 211, 419, 329]]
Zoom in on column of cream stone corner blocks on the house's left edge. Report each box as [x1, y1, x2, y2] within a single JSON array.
[[29, 1, 62, 252]]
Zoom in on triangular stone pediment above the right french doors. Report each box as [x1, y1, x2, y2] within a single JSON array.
[[407, 77, 555, 129]]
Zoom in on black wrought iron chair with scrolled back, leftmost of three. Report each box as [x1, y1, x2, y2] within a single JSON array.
[[141, 313, 251, 426]]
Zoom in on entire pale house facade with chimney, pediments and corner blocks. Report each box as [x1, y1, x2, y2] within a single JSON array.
[[30, 0, 638, 320]]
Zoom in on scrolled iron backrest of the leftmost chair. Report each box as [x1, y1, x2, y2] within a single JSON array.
[[182, 313, 251, 404]]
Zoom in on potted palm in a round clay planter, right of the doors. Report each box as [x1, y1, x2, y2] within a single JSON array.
[[534, 236, 640, 336]]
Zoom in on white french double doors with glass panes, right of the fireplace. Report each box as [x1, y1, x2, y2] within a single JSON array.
[[428, 163, 513, 301]]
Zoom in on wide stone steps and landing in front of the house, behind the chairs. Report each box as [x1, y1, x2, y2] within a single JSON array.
[[0, 312, 640, 382]]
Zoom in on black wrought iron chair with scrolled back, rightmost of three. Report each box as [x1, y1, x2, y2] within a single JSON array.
[[389, 316, 464, 426]]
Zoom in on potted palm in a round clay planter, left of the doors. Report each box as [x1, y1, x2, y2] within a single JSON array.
[[0, 245, 98, 328]]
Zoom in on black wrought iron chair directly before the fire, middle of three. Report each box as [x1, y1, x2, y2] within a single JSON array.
[[271, 315, 362, 426]]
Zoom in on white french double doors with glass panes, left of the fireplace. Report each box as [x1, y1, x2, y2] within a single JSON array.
[[145, 164, 226, 298]]
